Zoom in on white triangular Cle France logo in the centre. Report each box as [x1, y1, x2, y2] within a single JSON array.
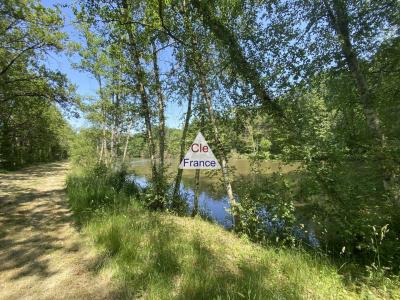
[[179, 132, 221, 169]]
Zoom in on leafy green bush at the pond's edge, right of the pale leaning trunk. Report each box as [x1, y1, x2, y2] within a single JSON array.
[[232, 173, 302, 246]]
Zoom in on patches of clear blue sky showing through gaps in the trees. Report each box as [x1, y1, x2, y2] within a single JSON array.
[[41, 0, 184, 129]]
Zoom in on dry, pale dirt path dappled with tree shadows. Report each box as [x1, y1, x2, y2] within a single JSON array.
[[0, 163, 114, 299]]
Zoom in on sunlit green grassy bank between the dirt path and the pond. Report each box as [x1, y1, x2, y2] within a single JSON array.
[[67, 170, 400, 299]]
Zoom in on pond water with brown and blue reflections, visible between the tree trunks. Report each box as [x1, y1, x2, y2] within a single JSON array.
[[130, 159, 318, 246]]
